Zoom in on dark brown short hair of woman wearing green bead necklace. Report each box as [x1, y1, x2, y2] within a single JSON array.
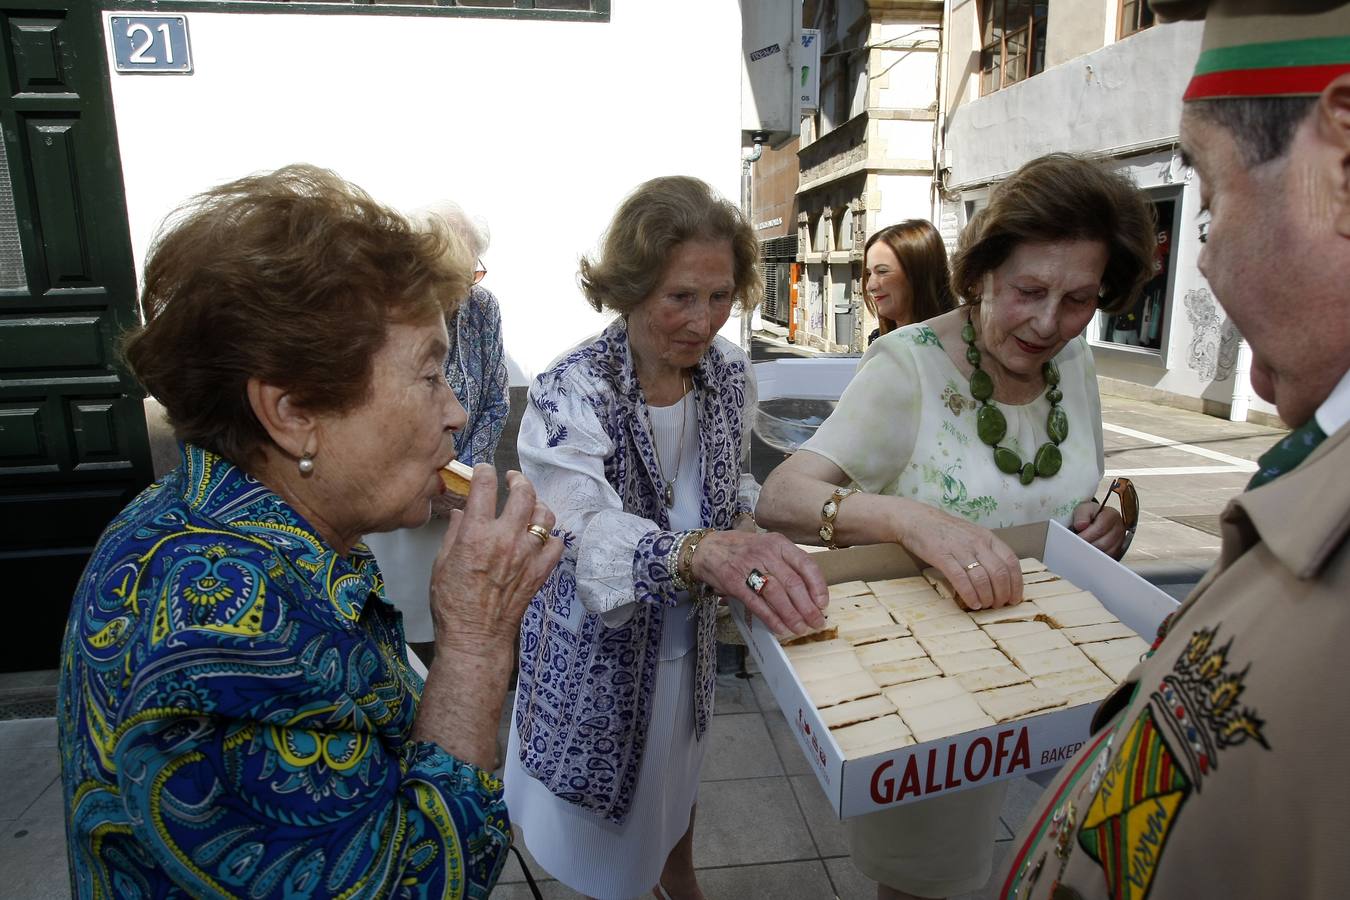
[[952, 152, 1157, 313]]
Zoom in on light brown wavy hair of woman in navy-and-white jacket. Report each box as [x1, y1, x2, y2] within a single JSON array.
[[581, 175, 764, 316]]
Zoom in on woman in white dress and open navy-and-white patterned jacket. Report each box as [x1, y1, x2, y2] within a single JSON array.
[[504, 177, 828, 900]]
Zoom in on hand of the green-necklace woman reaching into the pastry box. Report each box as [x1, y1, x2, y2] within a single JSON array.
[[898, 503, 1022, 610]]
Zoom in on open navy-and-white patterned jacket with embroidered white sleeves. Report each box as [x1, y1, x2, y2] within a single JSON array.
[[516, 318, 759, 823]]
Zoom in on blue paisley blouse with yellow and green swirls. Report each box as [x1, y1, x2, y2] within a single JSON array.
[[58, 445, 510, 899]]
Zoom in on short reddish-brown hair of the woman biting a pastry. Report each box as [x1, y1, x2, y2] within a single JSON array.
[[123, 165, 473, 466]]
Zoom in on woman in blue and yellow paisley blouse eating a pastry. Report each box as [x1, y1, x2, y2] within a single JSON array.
[[58, 166, 563, 897]]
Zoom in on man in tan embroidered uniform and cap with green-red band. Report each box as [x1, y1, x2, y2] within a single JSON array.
[[995, 0, 1350, 900]]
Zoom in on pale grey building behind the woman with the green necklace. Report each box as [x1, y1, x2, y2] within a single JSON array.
[[941, 0, 1277, 422]]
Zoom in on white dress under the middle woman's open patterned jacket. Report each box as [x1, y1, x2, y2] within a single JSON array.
[[502, 391, 707, 900]]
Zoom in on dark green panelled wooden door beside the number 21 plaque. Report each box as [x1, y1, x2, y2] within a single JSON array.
[[0, 0, 151, 672]]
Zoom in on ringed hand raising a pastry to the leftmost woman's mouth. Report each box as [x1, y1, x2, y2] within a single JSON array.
[[431, 463, 563, 653]]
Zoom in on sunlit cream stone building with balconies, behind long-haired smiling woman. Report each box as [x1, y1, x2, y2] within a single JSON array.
[[794, 0, 944, 352]]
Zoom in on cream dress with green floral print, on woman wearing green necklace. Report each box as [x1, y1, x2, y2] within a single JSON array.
[[802, 324, 1106, 897]]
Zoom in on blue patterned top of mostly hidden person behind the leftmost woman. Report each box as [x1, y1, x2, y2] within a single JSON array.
[[446, 285, 510, 466]]
